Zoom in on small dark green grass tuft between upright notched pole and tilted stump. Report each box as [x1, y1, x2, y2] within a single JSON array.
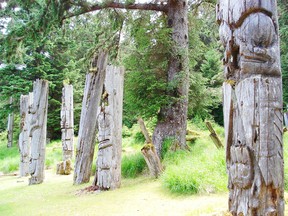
[[121, 152, 147, 178]]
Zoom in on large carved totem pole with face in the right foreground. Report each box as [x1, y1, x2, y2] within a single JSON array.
[[218, 0, 284, 216]]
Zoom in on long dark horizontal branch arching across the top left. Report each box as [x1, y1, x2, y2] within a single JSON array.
[[63, 2, 168, 19]]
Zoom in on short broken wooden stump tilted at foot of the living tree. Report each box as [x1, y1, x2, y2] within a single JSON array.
[[141, 143, 163, 178]]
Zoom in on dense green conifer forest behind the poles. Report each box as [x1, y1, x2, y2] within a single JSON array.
[[0, 0, 288, 170]]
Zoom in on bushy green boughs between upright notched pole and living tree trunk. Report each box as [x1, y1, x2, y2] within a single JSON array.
[[121, 12, 170, 123]]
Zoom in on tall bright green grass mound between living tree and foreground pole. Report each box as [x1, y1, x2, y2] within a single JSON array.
[[161, 137, 227, 194]]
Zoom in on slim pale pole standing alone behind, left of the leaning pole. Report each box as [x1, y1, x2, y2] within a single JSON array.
[[61, 85, 74, 161]]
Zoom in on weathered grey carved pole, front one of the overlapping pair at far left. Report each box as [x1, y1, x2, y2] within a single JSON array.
[[29, 79, 48, 185]]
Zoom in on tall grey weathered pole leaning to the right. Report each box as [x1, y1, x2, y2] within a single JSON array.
[[74, 52, 108, 184]]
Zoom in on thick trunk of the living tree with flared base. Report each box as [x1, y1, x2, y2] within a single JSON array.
[[153, 0, 189, 156]]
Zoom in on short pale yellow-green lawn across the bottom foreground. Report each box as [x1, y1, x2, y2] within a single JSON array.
[[0, 170, 227, 216]]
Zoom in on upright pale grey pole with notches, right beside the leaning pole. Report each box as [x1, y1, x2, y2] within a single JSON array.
[[93, 66, 124, 190]]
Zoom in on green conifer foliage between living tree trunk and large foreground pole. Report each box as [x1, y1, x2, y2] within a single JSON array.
[[188, 8, 223, 123]]
